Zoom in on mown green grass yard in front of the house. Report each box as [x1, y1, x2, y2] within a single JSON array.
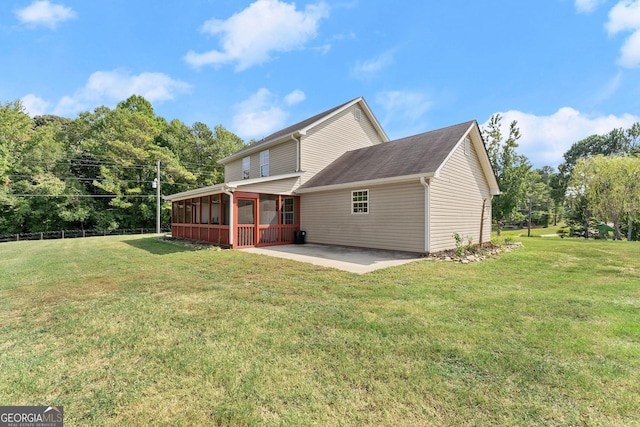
[[0, 236, 640, 426]]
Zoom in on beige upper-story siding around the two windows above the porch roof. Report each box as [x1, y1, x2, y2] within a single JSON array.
[[224, 141, 297, 182]]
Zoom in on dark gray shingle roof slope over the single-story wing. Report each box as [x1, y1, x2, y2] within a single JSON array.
[[300, 121, 476, 188]]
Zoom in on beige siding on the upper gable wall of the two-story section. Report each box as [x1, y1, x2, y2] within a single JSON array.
[[300, 104, 382, 184]]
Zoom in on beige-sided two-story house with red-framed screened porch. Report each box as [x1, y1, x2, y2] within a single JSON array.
[[165, 97, 499, 253]]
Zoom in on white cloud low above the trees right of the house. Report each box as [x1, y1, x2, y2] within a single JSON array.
[[481, 107, 640, 168]]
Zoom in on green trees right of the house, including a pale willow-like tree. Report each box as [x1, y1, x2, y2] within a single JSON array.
[[482, 114, 640, 240]]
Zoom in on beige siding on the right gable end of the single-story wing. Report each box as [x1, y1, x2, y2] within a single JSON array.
[[430, 138, 491, 252]]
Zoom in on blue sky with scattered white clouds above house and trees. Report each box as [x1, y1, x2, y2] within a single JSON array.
[[0, 0, 640, 167]]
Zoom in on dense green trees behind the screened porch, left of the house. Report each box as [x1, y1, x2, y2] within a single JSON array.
[[0, 95, 244, 234]]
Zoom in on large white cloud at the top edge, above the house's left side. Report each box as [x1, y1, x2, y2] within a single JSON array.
[[184, 0, 329, 71]]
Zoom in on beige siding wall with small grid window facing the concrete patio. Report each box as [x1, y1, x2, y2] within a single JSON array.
[[300, 179, 425, 253]]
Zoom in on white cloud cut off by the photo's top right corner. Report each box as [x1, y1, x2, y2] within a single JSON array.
[[606, 0, 640, 68]]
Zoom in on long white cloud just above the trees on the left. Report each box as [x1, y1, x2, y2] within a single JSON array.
[[54, 70, 190, 115]]
